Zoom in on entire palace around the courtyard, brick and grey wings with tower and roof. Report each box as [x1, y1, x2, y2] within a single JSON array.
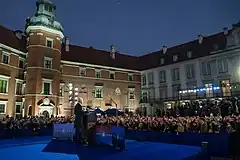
[[0, 0, 240, 116]]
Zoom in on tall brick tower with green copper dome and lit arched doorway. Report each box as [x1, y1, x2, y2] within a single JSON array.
[[24, 0, 64, 115]]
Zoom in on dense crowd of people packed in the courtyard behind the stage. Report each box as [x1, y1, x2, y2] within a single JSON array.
[[0, 99, 240, 136]]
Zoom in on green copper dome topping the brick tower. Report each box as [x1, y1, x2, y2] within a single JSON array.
[[25, 0, 63, 32]]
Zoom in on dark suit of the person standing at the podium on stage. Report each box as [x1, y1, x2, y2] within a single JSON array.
[[74, 103, 85, 141]]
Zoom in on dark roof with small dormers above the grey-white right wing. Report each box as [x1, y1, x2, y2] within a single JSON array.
[[139, 32, 226, 70]]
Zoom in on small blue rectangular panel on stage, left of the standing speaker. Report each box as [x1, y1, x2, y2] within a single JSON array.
[[53, 124, 75, 139]]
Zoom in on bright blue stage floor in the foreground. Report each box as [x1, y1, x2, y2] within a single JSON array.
[[0, 137, 201, 160]]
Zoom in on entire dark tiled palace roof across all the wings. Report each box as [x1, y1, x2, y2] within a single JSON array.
[[0, 25, 230, 70]]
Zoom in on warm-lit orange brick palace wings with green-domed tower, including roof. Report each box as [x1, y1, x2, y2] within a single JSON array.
[[0, 0, 141, 116]]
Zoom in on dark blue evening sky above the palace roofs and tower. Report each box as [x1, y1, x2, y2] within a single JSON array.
[[0, 0, 240, 55]]
